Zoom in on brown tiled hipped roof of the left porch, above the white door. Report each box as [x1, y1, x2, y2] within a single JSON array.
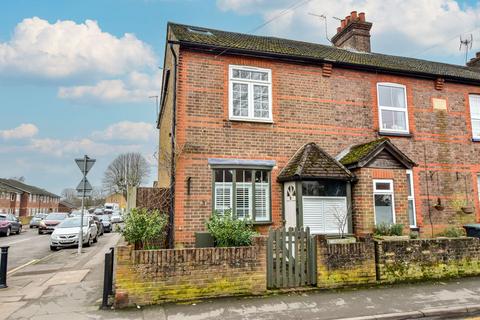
[[277, 142, 354, 181]]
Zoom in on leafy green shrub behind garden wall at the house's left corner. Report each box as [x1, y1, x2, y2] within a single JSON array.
[[122, 208, 168, 249]]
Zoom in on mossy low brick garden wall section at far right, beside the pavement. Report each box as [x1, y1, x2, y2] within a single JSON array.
[[376, 238, 480, 282]]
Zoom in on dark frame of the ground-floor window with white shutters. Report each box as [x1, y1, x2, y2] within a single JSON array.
[[211, 165, 272, 225]]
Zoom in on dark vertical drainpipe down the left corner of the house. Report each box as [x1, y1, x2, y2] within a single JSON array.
[[168, 43, 178, 248]]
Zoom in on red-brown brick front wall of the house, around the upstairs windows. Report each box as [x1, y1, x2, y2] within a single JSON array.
[[159, 50, 480, 246]]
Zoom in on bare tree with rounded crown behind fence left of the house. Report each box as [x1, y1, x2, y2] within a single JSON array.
[[103, 152, 150, 199]]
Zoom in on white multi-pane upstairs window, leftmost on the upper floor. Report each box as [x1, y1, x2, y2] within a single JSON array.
[[229, 66, 272, 122]]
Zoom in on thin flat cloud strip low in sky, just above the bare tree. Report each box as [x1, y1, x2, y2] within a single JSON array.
[[27, 138, 141, 158]]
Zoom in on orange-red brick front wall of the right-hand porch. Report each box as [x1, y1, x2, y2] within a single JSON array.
[[352, 168, 410, 235]]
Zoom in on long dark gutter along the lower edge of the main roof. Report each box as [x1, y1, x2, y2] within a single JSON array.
[[168, 40, 480, 86]]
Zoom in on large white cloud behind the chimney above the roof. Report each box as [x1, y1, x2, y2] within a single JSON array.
[[217, 0, 480, 59]]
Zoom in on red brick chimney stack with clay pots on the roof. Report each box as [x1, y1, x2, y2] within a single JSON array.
[[332, 11, 372, 52]]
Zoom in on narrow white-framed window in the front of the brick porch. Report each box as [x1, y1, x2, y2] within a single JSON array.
[[373, 180, 395, 225]]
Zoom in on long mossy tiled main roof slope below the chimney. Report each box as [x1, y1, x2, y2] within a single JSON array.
[[169, 22, 480, 84]]
